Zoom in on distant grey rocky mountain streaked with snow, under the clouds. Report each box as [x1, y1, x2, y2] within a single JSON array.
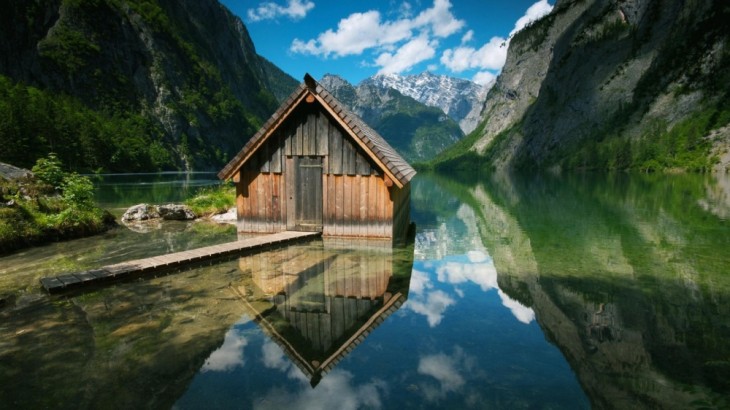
[[363, 72, 493, 134]]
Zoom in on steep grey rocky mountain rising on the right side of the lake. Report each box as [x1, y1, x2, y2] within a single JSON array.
[[435, 0, 730, 171]]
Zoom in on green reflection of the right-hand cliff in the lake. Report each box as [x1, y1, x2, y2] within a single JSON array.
[[450, 172, 730, 408]]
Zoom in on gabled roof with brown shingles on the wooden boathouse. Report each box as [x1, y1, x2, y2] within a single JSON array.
[[218, 74, 416, 188]]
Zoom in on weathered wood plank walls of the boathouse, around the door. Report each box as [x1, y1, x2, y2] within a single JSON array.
[[236, 103, 410, 238]]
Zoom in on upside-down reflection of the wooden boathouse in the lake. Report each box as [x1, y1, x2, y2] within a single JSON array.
[[234, 239, 413, 386]]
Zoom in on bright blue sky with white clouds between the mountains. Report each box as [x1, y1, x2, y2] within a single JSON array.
[[221, 0, 554, 84]]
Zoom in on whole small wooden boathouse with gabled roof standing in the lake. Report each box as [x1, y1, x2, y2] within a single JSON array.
[[218, 74, 416, 240]]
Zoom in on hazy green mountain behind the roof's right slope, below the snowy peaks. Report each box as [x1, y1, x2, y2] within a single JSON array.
[[320, 74, 464, 162]]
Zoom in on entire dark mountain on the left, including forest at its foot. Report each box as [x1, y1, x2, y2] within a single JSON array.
[[0, 0, 298, 171]]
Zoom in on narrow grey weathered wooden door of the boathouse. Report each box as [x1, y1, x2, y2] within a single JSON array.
[[294, 157, 322, 232]]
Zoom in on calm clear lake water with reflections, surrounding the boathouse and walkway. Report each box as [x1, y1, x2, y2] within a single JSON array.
[[0, 174, 730, 409]]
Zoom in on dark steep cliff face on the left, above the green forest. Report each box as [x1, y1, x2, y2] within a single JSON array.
[[0, 0, 297, 170]]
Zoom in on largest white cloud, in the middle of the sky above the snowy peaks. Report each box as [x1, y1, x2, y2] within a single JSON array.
[[289, 0, 465, 73]]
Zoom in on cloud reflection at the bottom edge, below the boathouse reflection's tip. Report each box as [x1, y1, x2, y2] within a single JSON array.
[[254, 369, 386, 410]]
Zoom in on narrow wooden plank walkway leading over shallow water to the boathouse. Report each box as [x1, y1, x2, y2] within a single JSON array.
[[41, 231, 321, 293]]
